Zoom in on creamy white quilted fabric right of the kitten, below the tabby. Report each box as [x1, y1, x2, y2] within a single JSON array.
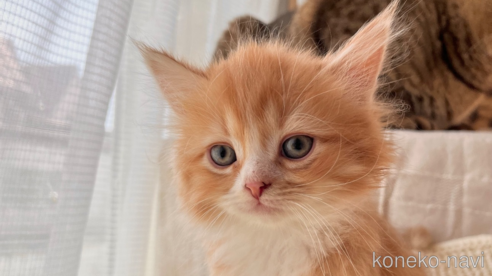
[[380, 131, 492, 242]]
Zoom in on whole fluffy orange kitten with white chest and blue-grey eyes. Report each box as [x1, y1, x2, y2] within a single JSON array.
[[141, 2, 422, 276]]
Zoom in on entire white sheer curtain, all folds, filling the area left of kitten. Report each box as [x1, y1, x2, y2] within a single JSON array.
[[0, 0, 287, 276]]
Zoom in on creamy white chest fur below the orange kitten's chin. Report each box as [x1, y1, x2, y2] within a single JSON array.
[[209, 225, 316, 276]]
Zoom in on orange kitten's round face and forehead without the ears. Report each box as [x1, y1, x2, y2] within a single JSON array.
[[175, 52, 383, 223]]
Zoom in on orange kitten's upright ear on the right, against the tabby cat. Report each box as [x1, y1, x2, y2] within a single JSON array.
[[327, 1, 398, 101]]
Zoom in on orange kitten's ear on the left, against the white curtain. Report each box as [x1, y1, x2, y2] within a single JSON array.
[[135, 42, 206, 111]]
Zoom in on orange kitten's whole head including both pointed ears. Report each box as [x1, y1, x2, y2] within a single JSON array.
[[140, 4, 390, 229]]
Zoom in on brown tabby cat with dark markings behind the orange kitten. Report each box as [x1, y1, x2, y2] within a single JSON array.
[[215, 0, 492, 130]]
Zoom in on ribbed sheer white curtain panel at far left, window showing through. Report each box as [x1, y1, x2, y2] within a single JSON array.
[[0, 0, 132, 276]]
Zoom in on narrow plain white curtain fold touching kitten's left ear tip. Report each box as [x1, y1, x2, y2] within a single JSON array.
[[109, 0, 179, 276]]
